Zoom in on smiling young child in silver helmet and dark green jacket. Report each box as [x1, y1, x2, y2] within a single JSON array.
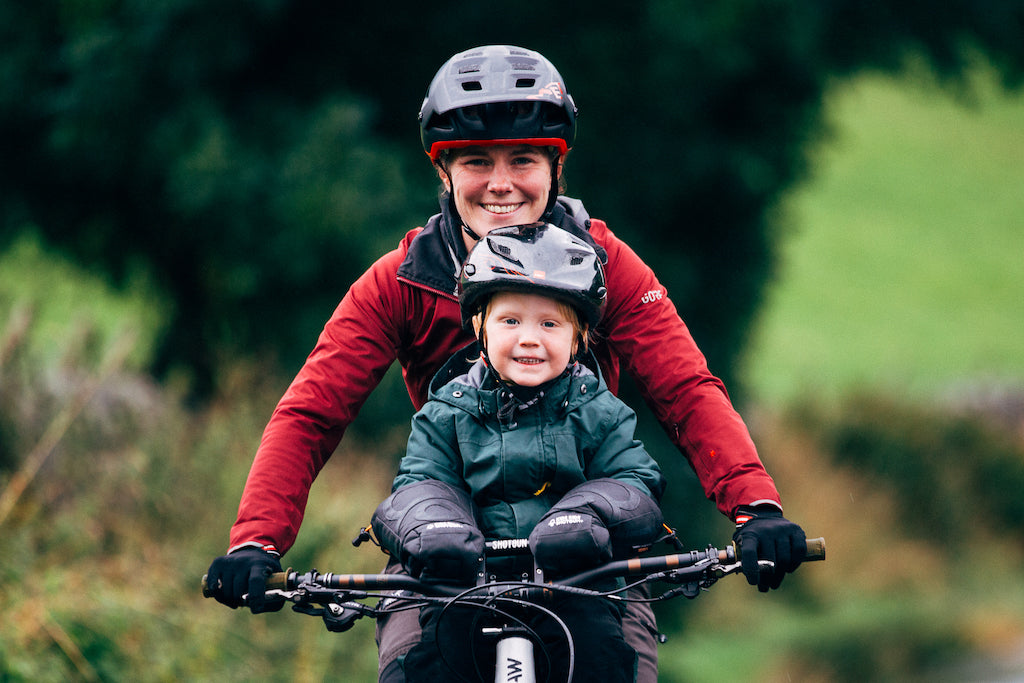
[[373, 223, 665, 681]]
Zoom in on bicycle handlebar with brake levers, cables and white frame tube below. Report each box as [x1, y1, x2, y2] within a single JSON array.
[[203, 539, 825, 681]]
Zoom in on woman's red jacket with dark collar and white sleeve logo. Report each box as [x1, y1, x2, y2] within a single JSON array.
[[230, 199, 781, 553]]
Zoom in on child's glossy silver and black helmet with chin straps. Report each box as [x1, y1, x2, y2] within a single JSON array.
[[459, 222, 608, 398]]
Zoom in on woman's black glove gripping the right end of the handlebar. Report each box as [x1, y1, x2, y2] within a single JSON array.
[[732, 505, 807, 593]]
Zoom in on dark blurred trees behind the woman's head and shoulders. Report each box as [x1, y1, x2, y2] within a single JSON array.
[[0, 0, 1024, 391]]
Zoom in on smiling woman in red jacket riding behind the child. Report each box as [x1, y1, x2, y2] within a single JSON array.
[[208, 45, 805, 681]]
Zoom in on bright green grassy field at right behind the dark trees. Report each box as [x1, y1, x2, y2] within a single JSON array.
[[743, 62, 1024, 404]]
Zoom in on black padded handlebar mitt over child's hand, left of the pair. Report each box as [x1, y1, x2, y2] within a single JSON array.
[[371, 479, 483, 584]]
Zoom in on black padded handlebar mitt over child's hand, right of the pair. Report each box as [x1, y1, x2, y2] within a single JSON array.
[[529, 479, 663, 575]]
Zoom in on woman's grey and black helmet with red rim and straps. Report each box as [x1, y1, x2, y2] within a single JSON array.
[[419, 45, 578, 241]]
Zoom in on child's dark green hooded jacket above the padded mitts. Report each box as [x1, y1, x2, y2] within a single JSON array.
[[393, 344, 665, 539]]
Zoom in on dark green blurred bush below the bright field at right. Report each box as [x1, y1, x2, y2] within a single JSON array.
[[797, 395, 1024, 552]]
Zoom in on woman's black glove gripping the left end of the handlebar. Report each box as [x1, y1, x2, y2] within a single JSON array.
[[206, 547, 285, 614]]
